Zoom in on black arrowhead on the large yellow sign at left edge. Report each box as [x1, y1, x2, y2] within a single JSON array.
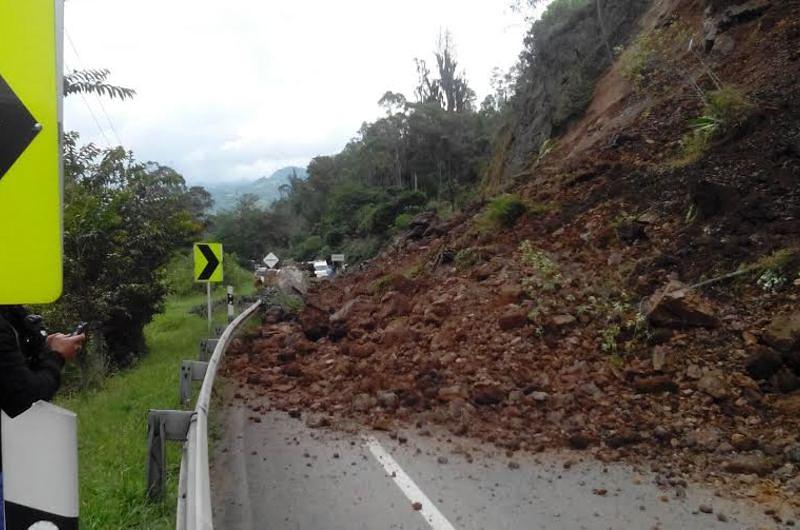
[[0, 75, 42, 180]]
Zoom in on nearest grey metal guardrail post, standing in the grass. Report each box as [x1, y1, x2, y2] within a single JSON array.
[[147, 409, 195, 500]]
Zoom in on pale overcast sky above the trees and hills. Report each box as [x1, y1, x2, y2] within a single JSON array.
[[65, 0, 544, 183]]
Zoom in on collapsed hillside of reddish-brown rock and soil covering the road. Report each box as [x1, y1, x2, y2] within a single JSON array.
[[223, 0, 800, 522]]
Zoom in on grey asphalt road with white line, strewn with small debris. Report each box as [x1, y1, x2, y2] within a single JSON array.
[[211, 394, 774, 530]]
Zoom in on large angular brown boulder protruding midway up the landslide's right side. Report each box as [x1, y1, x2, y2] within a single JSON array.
[[646, 281, 719, 329]]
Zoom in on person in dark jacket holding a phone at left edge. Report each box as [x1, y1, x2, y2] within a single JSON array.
[[0, 306, 86, 530]]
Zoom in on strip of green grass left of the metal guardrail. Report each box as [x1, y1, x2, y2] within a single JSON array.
[[56, 276, 252, 530]]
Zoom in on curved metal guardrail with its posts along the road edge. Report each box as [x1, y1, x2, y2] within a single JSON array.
[[147, 300, 263, 530]]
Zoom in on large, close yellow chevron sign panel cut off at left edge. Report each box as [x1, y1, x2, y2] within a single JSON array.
[[0, 0, 63, 304]]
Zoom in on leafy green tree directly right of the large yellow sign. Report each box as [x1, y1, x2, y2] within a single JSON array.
[[51, 133, 205, 366]]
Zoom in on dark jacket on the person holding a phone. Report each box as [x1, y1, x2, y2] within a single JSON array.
[[0, 306, 64, 469]]
